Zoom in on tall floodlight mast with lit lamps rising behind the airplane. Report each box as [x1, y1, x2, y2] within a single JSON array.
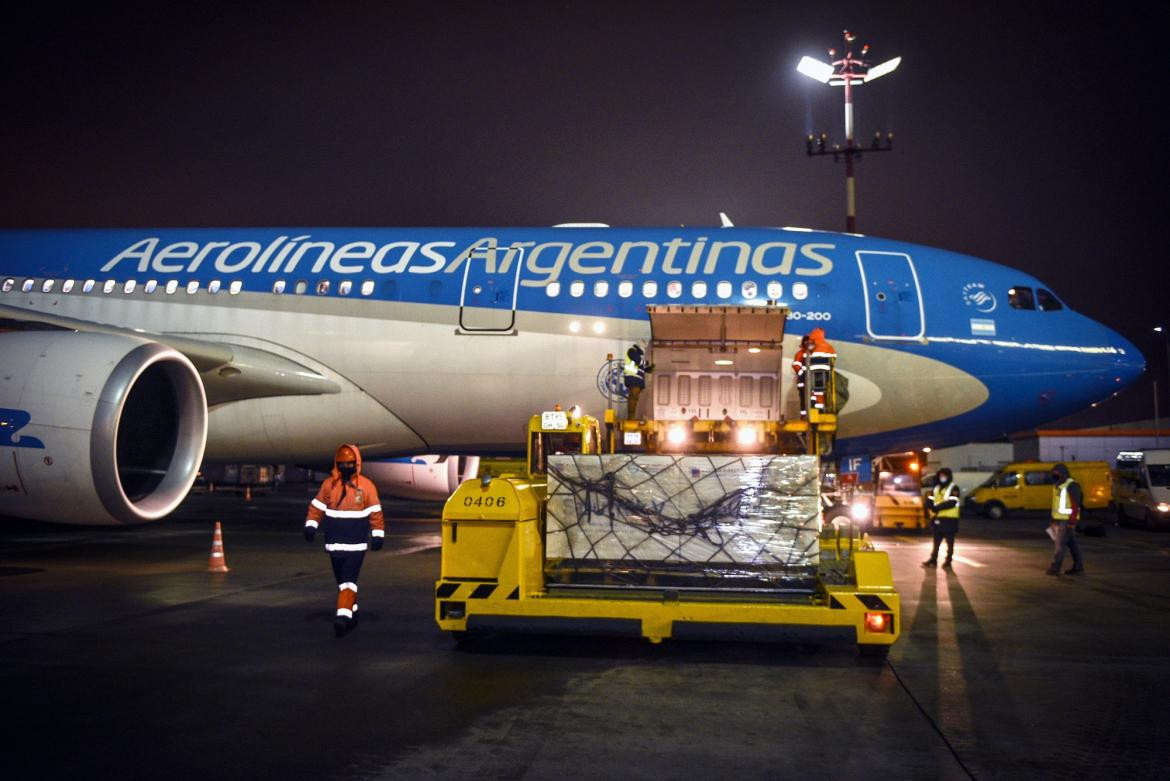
[[797, 30, 902, 233]]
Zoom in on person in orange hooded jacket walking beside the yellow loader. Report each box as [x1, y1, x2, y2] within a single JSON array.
[[304, 444, 386, 637]]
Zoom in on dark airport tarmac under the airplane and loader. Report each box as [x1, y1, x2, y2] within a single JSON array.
[[0, 486, 1170, 780]]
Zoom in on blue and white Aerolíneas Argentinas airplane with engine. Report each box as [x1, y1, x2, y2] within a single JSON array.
[[0, 225, 1144, 524]]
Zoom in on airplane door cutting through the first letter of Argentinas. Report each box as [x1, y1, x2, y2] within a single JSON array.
[[459, 247, 524, 333]]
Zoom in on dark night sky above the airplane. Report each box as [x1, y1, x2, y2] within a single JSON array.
[[0, 1, 1170, 424]]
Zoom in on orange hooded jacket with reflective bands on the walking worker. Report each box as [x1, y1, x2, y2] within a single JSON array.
[[304, 444, 386, 553]]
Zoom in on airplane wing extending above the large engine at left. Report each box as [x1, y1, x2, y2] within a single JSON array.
[[0, 305, 342, 407]]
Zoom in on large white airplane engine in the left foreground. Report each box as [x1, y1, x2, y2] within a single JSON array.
[[0, 331, 207, 525]]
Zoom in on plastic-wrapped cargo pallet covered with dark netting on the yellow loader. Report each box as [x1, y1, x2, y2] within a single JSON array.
[[545, 455, 820, 592]]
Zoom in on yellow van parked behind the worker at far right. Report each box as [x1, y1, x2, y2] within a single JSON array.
[[964, 461, 1113, 518]]
